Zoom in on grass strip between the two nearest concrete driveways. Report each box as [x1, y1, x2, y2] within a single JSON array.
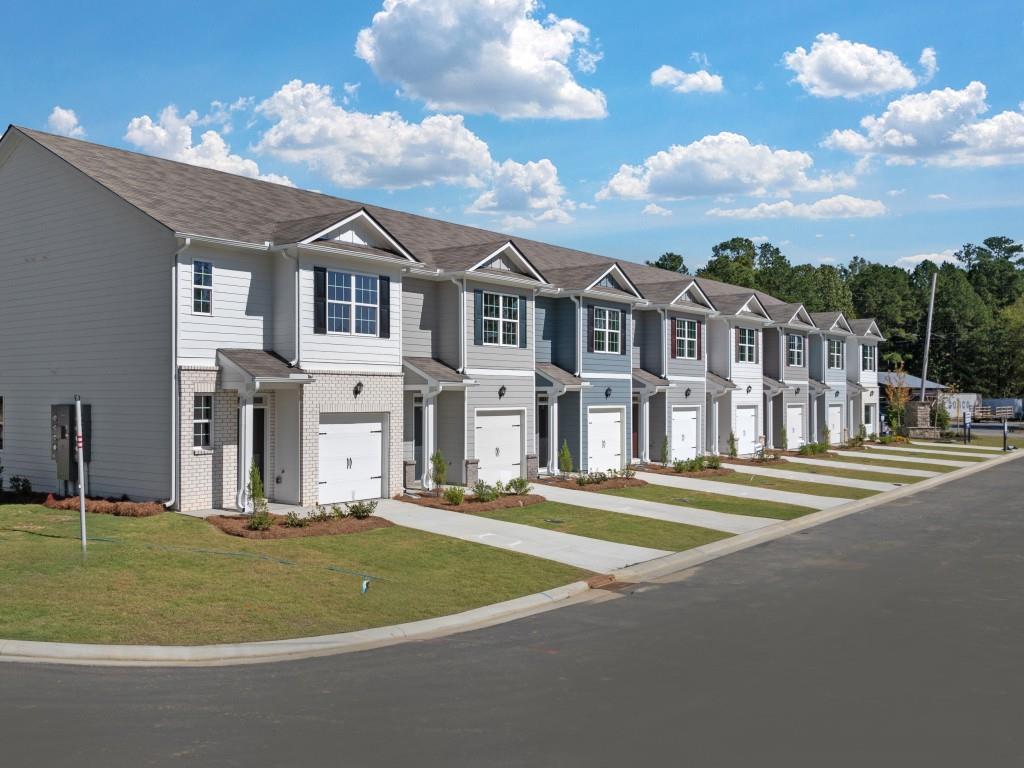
[[475, 502, 730, 552]]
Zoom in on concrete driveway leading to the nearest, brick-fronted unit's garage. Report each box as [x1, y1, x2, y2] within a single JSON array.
[[377, 499, 671, 573]]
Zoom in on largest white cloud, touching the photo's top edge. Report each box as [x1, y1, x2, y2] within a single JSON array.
[[355, 0, 607, 120]]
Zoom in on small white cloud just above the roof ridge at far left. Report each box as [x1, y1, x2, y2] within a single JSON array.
[[125, 102, 293, 186]]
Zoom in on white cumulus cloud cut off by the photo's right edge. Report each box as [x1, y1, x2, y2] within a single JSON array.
[[823, 81, 1024, 166]]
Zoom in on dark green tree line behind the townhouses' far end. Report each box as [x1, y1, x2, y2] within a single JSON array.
[[647, 237, 1024, 397]]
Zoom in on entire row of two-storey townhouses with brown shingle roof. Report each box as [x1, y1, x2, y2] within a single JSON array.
[[0, 127, 882, 510]]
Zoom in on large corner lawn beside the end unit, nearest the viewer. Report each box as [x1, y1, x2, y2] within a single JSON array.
[[0, 505, 589, 645]]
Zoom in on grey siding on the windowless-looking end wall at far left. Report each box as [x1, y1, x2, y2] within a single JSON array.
[[0, 136, 177, 500]]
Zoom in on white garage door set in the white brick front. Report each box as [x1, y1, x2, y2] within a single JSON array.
[[318, 420, 384, 504]]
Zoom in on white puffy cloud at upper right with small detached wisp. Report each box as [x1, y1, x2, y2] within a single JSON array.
[[782, 33, 937, 98]]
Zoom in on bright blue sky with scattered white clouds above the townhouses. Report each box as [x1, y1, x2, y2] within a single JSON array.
[[0, 0, 1024, 266]]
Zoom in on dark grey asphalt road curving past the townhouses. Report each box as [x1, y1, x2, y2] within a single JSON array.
[[0, 461, 1024, 768]]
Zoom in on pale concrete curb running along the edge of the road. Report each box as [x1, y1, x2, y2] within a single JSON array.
[[0, 451, 1024, 667]]
